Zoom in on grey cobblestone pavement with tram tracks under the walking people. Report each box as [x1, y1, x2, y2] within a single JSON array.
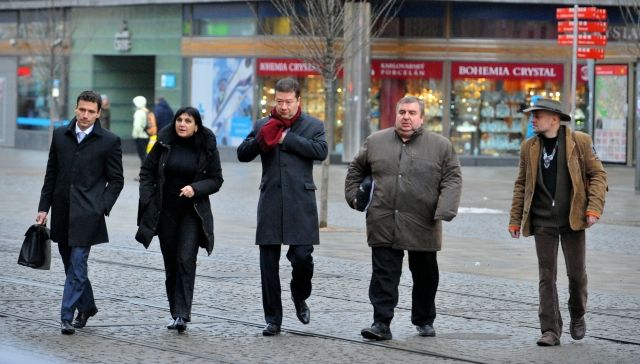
[[0, 148, 640, 363]]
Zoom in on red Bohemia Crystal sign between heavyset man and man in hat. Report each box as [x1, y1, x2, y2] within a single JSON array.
[[451, 62, 564, 81]]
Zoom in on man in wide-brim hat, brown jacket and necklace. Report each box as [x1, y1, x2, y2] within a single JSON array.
[[509, 98, 607, 346]]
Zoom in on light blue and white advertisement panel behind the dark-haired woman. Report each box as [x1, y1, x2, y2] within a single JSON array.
[[191, 58, 255, 146]]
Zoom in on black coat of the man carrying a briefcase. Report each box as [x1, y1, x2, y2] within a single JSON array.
[[38, 118, 124, 247]]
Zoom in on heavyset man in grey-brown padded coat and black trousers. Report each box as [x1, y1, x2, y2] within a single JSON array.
[[345, 96, 462, 340]]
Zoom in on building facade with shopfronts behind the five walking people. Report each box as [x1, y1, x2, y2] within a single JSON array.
[[0, 0, 640, 165]]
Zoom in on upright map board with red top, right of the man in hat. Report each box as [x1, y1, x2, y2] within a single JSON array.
[[594, 65, 628, 163]]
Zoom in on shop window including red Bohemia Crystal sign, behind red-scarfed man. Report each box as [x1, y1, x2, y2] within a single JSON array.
[[257, 59, 344, 151]]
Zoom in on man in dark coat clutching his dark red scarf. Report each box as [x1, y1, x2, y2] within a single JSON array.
[[238, 78, 327, 336]]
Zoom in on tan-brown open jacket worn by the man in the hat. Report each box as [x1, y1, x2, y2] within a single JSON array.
[[509, 126, 607, 236]]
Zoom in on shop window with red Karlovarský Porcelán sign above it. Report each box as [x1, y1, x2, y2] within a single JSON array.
[[370, 60, 443, 133]]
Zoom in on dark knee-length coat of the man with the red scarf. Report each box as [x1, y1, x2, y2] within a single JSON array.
[[237, 113, 327, 245]]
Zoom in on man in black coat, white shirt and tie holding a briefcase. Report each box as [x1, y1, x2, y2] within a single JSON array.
[[36, 91, 124, 334]]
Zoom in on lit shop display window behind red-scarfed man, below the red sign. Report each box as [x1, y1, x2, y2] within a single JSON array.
[[258, 75, 344, 150]]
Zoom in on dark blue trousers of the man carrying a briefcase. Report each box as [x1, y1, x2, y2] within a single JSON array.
[[58, 243, 96, 321]]
